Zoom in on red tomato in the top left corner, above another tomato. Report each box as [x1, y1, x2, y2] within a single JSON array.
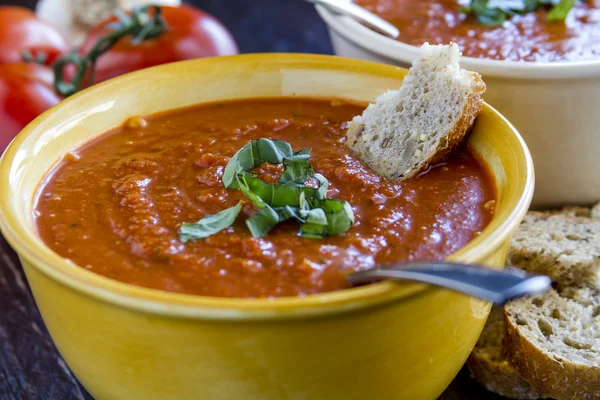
[[0, 6, 68, 65]]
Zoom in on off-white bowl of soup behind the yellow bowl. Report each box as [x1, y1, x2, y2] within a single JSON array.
[[316, 6, 600, 207]]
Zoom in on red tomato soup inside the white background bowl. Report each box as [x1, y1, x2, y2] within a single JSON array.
[[355, 0, 600, 62]]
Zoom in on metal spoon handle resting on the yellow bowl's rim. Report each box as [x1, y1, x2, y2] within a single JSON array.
[[346, 261, 551, 305]]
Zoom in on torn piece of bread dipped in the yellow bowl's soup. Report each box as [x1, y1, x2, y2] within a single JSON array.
[[346, 43, 485, 180]]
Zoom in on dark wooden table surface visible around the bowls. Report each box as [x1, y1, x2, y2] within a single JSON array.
[[0, 0, 500, 400]]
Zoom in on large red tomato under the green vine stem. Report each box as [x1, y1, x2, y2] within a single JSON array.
[[81, 5, 238, 83]]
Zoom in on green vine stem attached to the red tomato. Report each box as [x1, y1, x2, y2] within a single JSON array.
[[52, 6, 167, 97]]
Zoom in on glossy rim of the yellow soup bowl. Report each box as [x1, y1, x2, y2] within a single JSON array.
[[0, 53, 534, 320]]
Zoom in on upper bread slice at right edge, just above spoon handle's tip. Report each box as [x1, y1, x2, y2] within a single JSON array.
[[508, 212, 600, 286]]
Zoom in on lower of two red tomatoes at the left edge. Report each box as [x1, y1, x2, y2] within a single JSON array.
[[0, 64, 60, 154]]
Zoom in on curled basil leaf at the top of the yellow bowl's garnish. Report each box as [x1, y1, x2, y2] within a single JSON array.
[[222, 138, 294, 189]]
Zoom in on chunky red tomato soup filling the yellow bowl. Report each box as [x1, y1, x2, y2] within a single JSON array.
[[36, 98, 495, 297]]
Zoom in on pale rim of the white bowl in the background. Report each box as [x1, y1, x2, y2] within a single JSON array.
[[315, 0, 600, 80]]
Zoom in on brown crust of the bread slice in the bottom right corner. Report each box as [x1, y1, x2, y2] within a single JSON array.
[[504, 314, 600, 400]]
